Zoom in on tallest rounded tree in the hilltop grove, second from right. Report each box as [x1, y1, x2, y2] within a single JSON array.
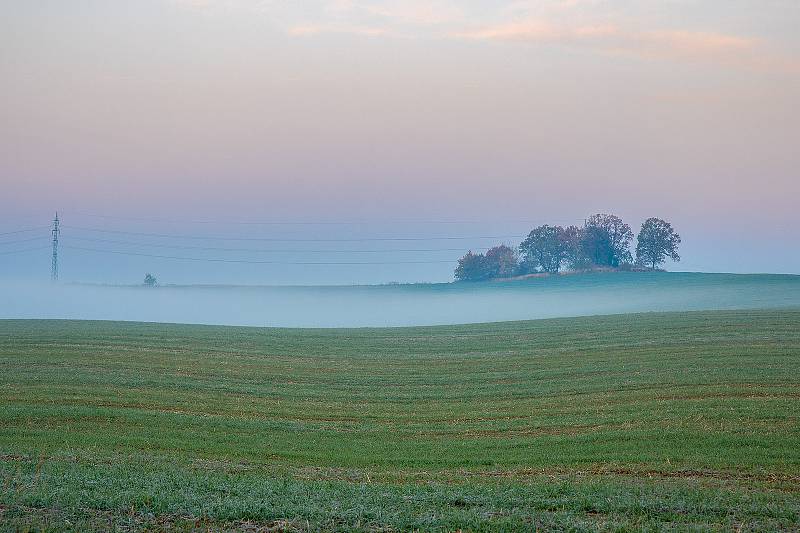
[[581, 214, 633, 268]]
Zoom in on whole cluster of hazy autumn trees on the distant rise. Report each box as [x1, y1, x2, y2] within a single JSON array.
[[455, 214, 681, 281]]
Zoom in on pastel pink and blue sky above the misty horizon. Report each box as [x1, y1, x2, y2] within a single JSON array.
[[0, 0, 800, 284]]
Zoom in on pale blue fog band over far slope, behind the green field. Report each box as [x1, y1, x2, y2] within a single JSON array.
[[0, 273, 800, 327]]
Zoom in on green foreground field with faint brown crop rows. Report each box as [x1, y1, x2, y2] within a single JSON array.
[[0, 310, 800, 531]]
